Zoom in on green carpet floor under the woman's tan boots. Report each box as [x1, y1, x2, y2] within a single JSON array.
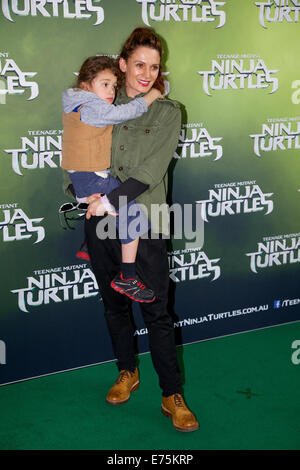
[[0, 322, 300, 450]]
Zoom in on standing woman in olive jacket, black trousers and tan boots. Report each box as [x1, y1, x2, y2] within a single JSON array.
[[86, 28, 199, 431]]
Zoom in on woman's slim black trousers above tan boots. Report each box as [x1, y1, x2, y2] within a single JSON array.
[[85, 217, 182, 396]]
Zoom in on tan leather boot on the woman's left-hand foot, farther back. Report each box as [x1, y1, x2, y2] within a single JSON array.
[[106, 369, 140, 405]]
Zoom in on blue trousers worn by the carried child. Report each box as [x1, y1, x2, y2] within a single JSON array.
[[69, 171, 150, 244]]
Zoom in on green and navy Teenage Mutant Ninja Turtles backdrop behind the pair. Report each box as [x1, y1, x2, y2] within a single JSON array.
[[0, 0, 300, 384]]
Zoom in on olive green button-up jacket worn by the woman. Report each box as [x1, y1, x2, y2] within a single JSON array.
[[64, 89, 181, 234]]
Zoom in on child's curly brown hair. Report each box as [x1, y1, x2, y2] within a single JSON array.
[[75, 55, 121, 88]]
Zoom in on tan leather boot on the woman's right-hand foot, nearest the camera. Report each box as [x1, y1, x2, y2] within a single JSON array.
[[161, 393, 199, 432]]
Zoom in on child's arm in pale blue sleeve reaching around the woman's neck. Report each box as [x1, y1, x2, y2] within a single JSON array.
[[80, 89, 162, 127]]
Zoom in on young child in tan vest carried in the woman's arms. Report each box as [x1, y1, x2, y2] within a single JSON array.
[[61, 56, 162, 302]]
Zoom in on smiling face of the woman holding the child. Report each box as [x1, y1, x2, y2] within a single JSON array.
[[119, 46, 160, 98]]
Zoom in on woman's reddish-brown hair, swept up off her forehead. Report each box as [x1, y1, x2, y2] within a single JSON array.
[[120, 28, 165, 93]]
